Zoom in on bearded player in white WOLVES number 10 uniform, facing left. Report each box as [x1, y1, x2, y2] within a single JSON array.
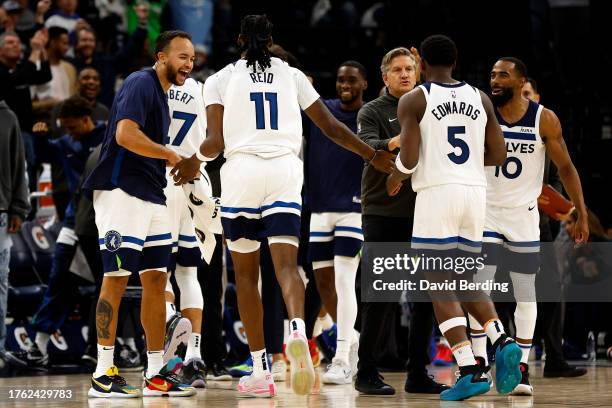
[[470, 57, 589, 395]]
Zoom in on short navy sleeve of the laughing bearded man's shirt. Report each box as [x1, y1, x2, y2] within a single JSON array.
[[115, 76, 156, 129]]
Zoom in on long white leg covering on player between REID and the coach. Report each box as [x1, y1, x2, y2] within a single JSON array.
[[334, 256, 359, 363]]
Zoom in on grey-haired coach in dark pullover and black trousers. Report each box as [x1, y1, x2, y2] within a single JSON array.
[[355, 47, 445, 395]]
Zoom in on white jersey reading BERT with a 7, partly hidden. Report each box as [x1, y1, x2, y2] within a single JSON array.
[[166, 78, 206, 157]]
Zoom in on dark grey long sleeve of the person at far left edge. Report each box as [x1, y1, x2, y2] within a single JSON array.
[[8, 117, 30, 219]]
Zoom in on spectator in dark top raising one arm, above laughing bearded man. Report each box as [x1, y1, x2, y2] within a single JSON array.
[[70, 8, 149, 106]]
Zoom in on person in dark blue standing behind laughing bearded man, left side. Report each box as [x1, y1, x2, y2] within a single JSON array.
[[28, 95, 106, 367]]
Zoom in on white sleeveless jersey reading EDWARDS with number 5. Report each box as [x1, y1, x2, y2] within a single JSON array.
[[412, 82, 487, 192]]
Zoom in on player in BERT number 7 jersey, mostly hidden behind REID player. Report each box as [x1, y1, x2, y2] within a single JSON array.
[[164, 78, 206, 388]]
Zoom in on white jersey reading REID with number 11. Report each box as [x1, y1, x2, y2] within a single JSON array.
[[204, 58, 319, 158]]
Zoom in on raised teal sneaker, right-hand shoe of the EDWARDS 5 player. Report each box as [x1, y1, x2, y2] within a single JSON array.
[[493, 334, 523, 394]]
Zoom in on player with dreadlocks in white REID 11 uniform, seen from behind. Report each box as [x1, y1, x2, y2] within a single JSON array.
[[173, 15, 393, 397]]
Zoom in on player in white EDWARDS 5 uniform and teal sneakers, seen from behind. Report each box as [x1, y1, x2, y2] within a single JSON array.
[[387, 35, 521, 401]]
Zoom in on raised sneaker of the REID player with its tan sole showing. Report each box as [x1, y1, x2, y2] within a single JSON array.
[[286, 330, 315, 395]]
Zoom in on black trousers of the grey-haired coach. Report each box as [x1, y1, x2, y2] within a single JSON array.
[[359, 215, 433, 372]]
